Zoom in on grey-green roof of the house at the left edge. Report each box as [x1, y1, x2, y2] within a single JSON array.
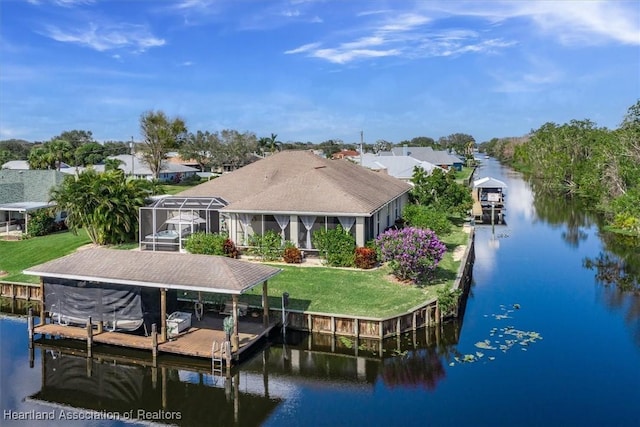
[[0, 169, 65, 204]]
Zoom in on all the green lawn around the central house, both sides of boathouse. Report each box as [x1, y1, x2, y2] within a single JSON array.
[[0, 229, 469, 317]]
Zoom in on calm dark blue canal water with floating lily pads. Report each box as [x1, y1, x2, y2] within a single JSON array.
[[0, 160, 640, 426]]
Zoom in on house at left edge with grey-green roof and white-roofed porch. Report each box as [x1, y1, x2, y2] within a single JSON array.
[[0, 169, 65, 233]]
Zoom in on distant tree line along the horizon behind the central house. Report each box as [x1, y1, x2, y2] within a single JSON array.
[[0, 111, 475, 178]]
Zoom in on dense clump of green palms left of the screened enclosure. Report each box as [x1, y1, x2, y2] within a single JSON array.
[[50, 169, 152, 245]]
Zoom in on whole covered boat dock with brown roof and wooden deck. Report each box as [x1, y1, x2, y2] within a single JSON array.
[[24, 248, 282, 364]]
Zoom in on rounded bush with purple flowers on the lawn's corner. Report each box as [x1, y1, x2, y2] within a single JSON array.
[[376, 227, 447, 283]]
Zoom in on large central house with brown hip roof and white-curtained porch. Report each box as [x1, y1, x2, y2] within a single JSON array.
[[141, 151, 411, 250]]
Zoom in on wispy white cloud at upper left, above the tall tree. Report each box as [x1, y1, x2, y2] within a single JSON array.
[[46, 24, 165, 52]]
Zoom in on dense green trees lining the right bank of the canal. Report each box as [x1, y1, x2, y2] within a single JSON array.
[[480, 100, 640, 233]]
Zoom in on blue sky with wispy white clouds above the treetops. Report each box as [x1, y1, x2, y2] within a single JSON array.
[[0, 0, 640, 143]]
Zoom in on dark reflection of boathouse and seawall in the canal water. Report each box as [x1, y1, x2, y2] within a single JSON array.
[[11, 319, 460, 426]]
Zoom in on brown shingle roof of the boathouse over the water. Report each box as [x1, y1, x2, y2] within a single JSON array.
[[24, 248, 281, 294]]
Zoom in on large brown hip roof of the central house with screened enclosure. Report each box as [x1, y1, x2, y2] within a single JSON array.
[[178, 151, 411, 215]]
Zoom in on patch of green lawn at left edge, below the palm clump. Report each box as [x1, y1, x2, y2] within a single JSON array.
[[0, 231, 91, 283]]
